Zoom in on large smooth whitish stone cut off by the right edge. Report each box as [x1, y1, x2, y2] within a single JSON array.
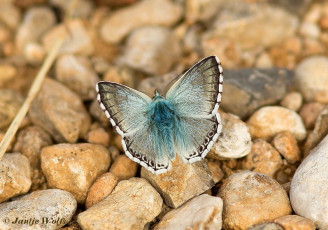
[[290, 136, 328, 229]]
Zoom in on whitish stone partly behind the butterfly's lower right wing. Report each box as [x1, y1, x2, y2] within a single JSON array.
[[207, 113, 253, 160]]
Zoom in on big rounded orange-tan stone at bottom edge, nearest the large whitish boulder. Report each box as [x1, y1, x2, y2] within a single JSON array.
[[219, 171, 292, 230]]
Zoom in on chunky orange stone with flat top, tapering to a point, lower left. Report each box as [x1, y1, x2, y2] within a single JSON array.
[[41, 143, 110, 204]]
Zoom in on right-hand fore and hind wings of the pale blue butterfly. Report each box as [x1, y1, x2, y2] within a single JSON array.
[[166, 56, 223, 163]]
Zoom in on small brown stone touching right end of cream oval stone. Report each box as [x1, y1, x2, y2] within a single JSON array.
[[299, 102, 325, 129]]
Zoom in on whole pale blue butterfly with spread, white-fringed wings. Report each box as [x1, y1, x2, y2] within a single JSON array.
[[96, 56, 223, 174]]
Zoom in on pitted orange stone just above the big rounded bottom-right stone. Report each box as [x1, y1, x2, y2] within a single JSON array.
[[241, 139, 283, 178]]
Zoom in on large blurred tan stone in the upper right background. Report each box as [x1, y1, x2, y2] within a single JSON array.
[[205, 2, 298, 51]]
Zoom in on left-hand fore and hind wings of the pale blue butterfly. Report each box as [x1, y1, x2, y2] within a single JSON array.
[[96, 81, 170, 174]]
